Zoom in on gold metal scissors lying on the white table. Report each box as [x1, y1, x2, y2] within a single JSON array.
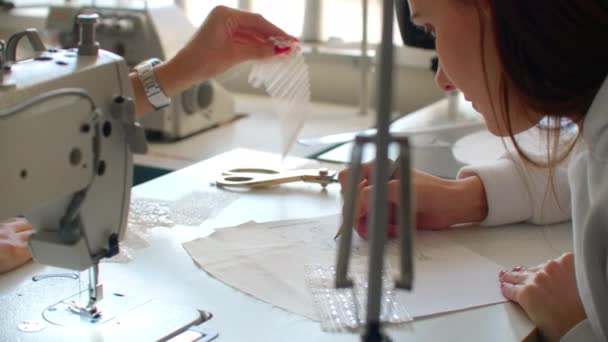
[[216, 168, 338, 188]]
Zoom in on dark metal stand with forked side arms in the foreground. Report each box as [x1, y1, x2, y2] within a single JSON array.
[[336, 0, 415, 342]]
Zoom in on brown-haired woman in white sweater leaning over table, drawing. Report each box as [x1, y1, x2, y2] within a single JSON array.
[[341, 0, 608, 341]]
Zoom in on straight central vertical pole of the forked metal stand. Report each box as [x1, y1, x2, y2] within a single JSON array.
[[364, 0, 394, 341]]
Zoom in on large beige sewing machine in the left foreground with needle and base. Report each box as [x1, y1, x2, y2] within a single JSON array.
[[0, 18, 216, 340]]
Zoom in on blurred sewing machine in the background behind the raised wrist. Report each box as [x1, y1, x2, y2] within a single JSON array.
[[46, 2, 235, 140]]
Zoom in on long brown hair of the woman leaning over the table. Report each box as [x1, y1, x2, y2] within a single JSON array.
[[478, 0, 608, 167]]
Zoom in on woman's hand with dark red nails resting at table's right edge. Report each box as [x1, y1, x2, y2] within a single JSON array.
[[499, 253, 586, 341]]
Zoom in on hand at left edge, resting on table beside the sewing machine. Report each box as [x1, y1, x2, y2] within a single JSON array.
[[0, 218, 32, 273]]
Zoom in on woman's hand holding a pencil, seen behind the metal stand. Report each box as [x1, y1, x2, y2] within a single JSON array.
[[339, 163, 487, 238]]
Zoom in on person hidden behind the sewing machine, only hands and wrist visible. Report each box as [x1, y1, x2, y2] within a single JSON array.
[[0, 6, 296, 273]]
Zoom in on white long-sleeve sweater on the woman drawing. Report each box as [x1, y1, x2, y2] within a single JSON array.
[[458, 78, 608, 341]]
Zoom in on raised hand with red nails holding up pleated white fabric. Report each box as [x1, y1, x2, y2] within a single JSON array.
[[155, 6, 297, 96]]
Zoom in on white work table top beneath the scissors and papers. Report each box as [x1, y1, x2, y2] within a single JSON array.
[[0, 149, 571, 341]]
